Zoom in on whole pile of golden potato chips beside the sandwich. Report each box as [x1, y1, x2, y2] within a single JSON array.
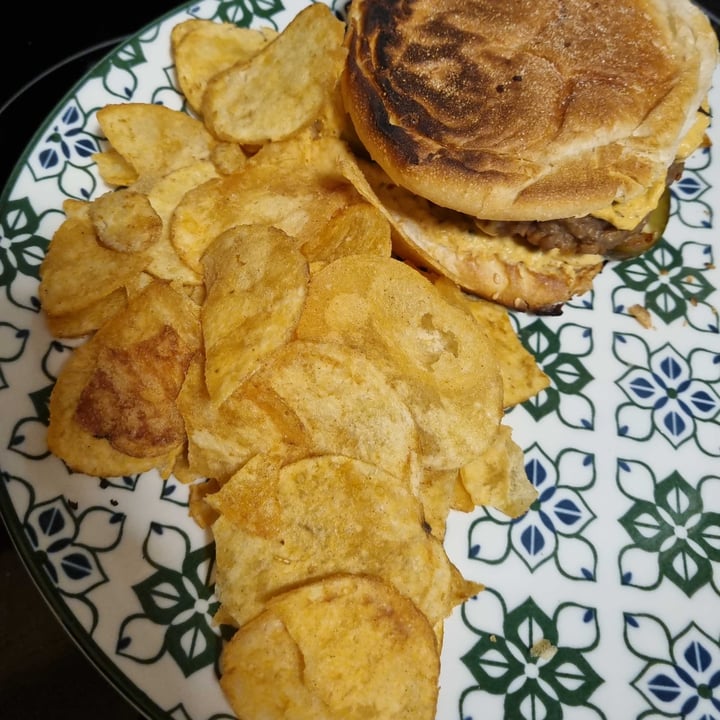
[[40, 4, 548, 720]]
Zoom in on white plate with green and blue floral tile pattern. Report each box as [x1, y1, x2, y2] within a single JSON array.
[[0, 0, 720, 720]]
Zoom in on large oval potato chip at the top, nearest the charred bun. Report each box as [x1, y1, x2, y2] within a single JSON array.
[[201, 3, 347, 145]]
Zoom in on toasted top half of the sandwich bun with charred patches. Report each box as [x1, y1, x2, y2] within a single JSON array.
[[342, 0, 718, 220]]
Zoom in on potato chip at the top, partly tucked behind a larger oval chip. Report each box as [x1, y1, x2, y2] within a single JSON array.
[[171, 19, 277, 114]]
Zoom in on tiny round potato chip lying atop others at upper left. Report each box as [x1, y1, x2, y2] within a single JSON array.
[[88, 188, 162, 253]]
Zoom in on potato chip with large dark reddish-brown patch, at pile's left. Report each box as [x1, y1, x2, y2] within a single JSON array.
[[47, 282, 200, 477]]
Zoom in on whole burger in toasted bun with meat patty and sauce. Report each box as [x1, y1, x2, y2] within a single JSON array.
[[342, 0, 718, 312]]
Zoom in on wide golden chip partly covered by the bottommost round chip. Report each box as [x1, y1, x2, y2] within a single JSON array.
[[207, 455, 480, 626]]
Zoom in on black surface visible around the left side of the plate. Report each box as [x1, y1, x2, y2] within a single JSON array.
[[0, 0, 182, 720]]
